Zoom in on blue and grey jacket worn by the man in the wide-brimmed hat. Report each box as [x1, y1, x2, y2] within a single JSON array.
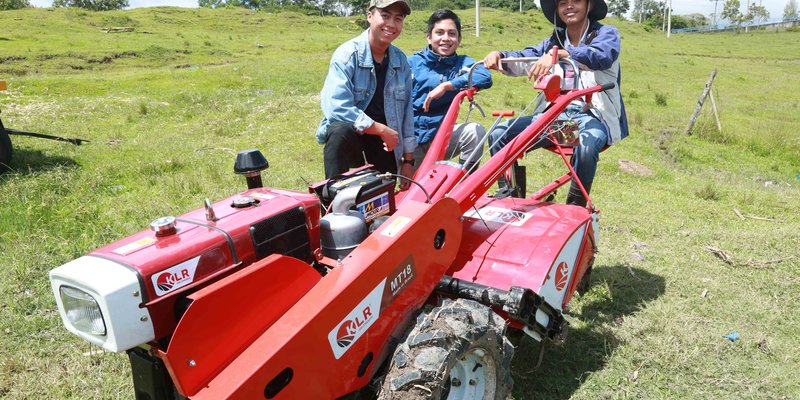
[[501, 21, 628, 145]]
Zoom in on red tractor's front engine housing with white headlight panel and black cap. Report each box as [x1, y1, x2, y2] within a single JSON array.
[[50, 150, 320, 352]]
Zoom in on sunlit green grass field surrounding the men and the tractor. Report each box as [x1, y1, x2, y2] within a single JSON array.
[[0, 8, 800, 399]]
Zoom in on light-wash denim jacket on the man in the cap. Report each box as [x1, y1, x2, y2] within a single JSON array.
[[317, 30, 417, 164]]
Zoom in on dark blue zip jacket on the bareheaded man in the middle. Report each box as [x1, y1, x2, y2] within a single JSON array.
[[408, 46, 492, 143]]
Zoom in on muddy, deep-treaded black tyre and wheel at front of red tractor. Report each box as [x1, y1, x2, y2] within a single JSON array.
[[378, 299, 514, 400]]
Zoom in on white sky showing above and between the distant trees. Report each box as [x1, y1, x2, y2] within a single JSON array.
[[31, 0, 788, 19]]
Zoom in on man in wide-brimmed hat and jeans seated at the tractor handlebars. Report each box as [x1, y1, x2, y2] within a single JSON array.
[[485, 0, 628, 206]]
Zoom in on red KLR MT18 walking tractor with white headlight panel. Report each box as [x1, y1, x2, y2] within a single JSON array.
[[50, 56, 607, 399]]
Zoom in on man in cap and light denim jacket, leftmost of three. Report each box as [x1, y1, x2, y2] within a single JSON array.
[[317, 0, 416, 187]]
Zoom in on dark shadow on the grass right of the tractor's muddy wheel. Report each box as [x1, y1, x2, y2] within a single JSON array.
[[512, 265, 665, 400]]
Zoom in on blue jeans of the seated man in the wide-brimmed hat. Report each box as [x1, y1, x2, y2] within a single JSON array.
[[489, 105, 608, 197]]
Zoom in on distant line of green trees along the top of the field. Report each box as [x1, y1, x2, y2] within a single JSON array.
[[0, 0, 798, 29]]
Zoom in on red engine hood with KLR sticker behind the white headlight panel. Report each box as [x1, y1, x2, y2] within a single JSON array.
[[51, 188, 320, 351]]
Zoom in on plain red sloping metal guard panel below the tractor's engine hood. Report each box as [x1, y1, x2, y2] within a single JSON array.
[[162, 254, 322, 393]]
